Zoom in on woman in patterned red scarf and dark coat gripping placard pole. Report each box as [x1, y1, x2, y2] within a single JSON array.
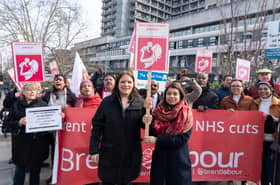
[[143, 77, 202, 185]]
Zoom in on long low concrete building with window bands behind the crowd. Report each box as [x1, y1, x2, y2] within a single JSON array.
[[78, 0, 280, 75]]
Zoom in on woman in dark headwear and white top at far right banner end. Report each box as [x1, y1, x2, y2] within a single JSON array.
[[254, 82, 280, 185]]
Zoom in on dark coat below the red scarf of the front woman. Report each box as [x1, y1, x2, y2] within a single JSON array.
[[150, 130, 192, 185]]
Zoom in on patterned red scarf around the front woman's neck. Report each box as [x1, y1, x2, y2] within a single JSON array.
[[153, 100, 193, 136]]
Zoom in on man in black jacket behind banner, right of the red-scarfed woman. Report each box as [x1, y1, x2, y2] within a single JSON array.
[[193, 73, 219, 111]]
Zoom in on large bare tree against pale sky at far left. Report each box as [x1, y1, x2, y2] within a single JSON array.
[[0, 0, 85, 72]]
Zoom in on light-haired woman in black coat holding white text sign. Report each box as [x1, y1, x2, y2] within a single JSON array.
[[7, 83, 49, 185]]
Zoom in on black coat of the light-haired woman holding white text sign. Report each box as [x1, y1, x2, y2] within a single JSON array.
[[9, 98, 49, 168]]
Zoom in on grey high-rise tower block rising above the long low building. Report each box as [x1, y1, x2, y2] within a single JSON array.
[[101, 0, 220, 37]]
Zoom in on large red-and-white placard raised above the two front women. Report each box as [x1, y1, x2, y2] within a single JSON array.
[[134, 22, 169, 72]]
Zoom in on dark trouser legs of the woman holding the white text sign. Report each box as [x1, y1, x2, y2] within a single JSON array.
[[13, 165, 41, 185]]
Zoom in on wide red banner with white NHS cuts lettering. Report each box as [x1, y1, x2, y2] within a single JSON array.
[[57, 108, 264, 185]]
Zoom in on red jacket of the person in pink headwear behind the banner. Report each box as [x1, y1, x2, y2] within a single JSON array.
[[75, 93, 102, 109]]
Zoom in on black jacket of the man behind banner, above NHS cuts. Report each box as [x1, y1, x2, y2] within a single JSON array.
[[193, 86, 219, 109]]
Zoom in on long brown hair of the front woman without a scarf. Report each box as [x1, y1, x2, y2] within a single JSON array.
[[111, 71, 140, 102]]
